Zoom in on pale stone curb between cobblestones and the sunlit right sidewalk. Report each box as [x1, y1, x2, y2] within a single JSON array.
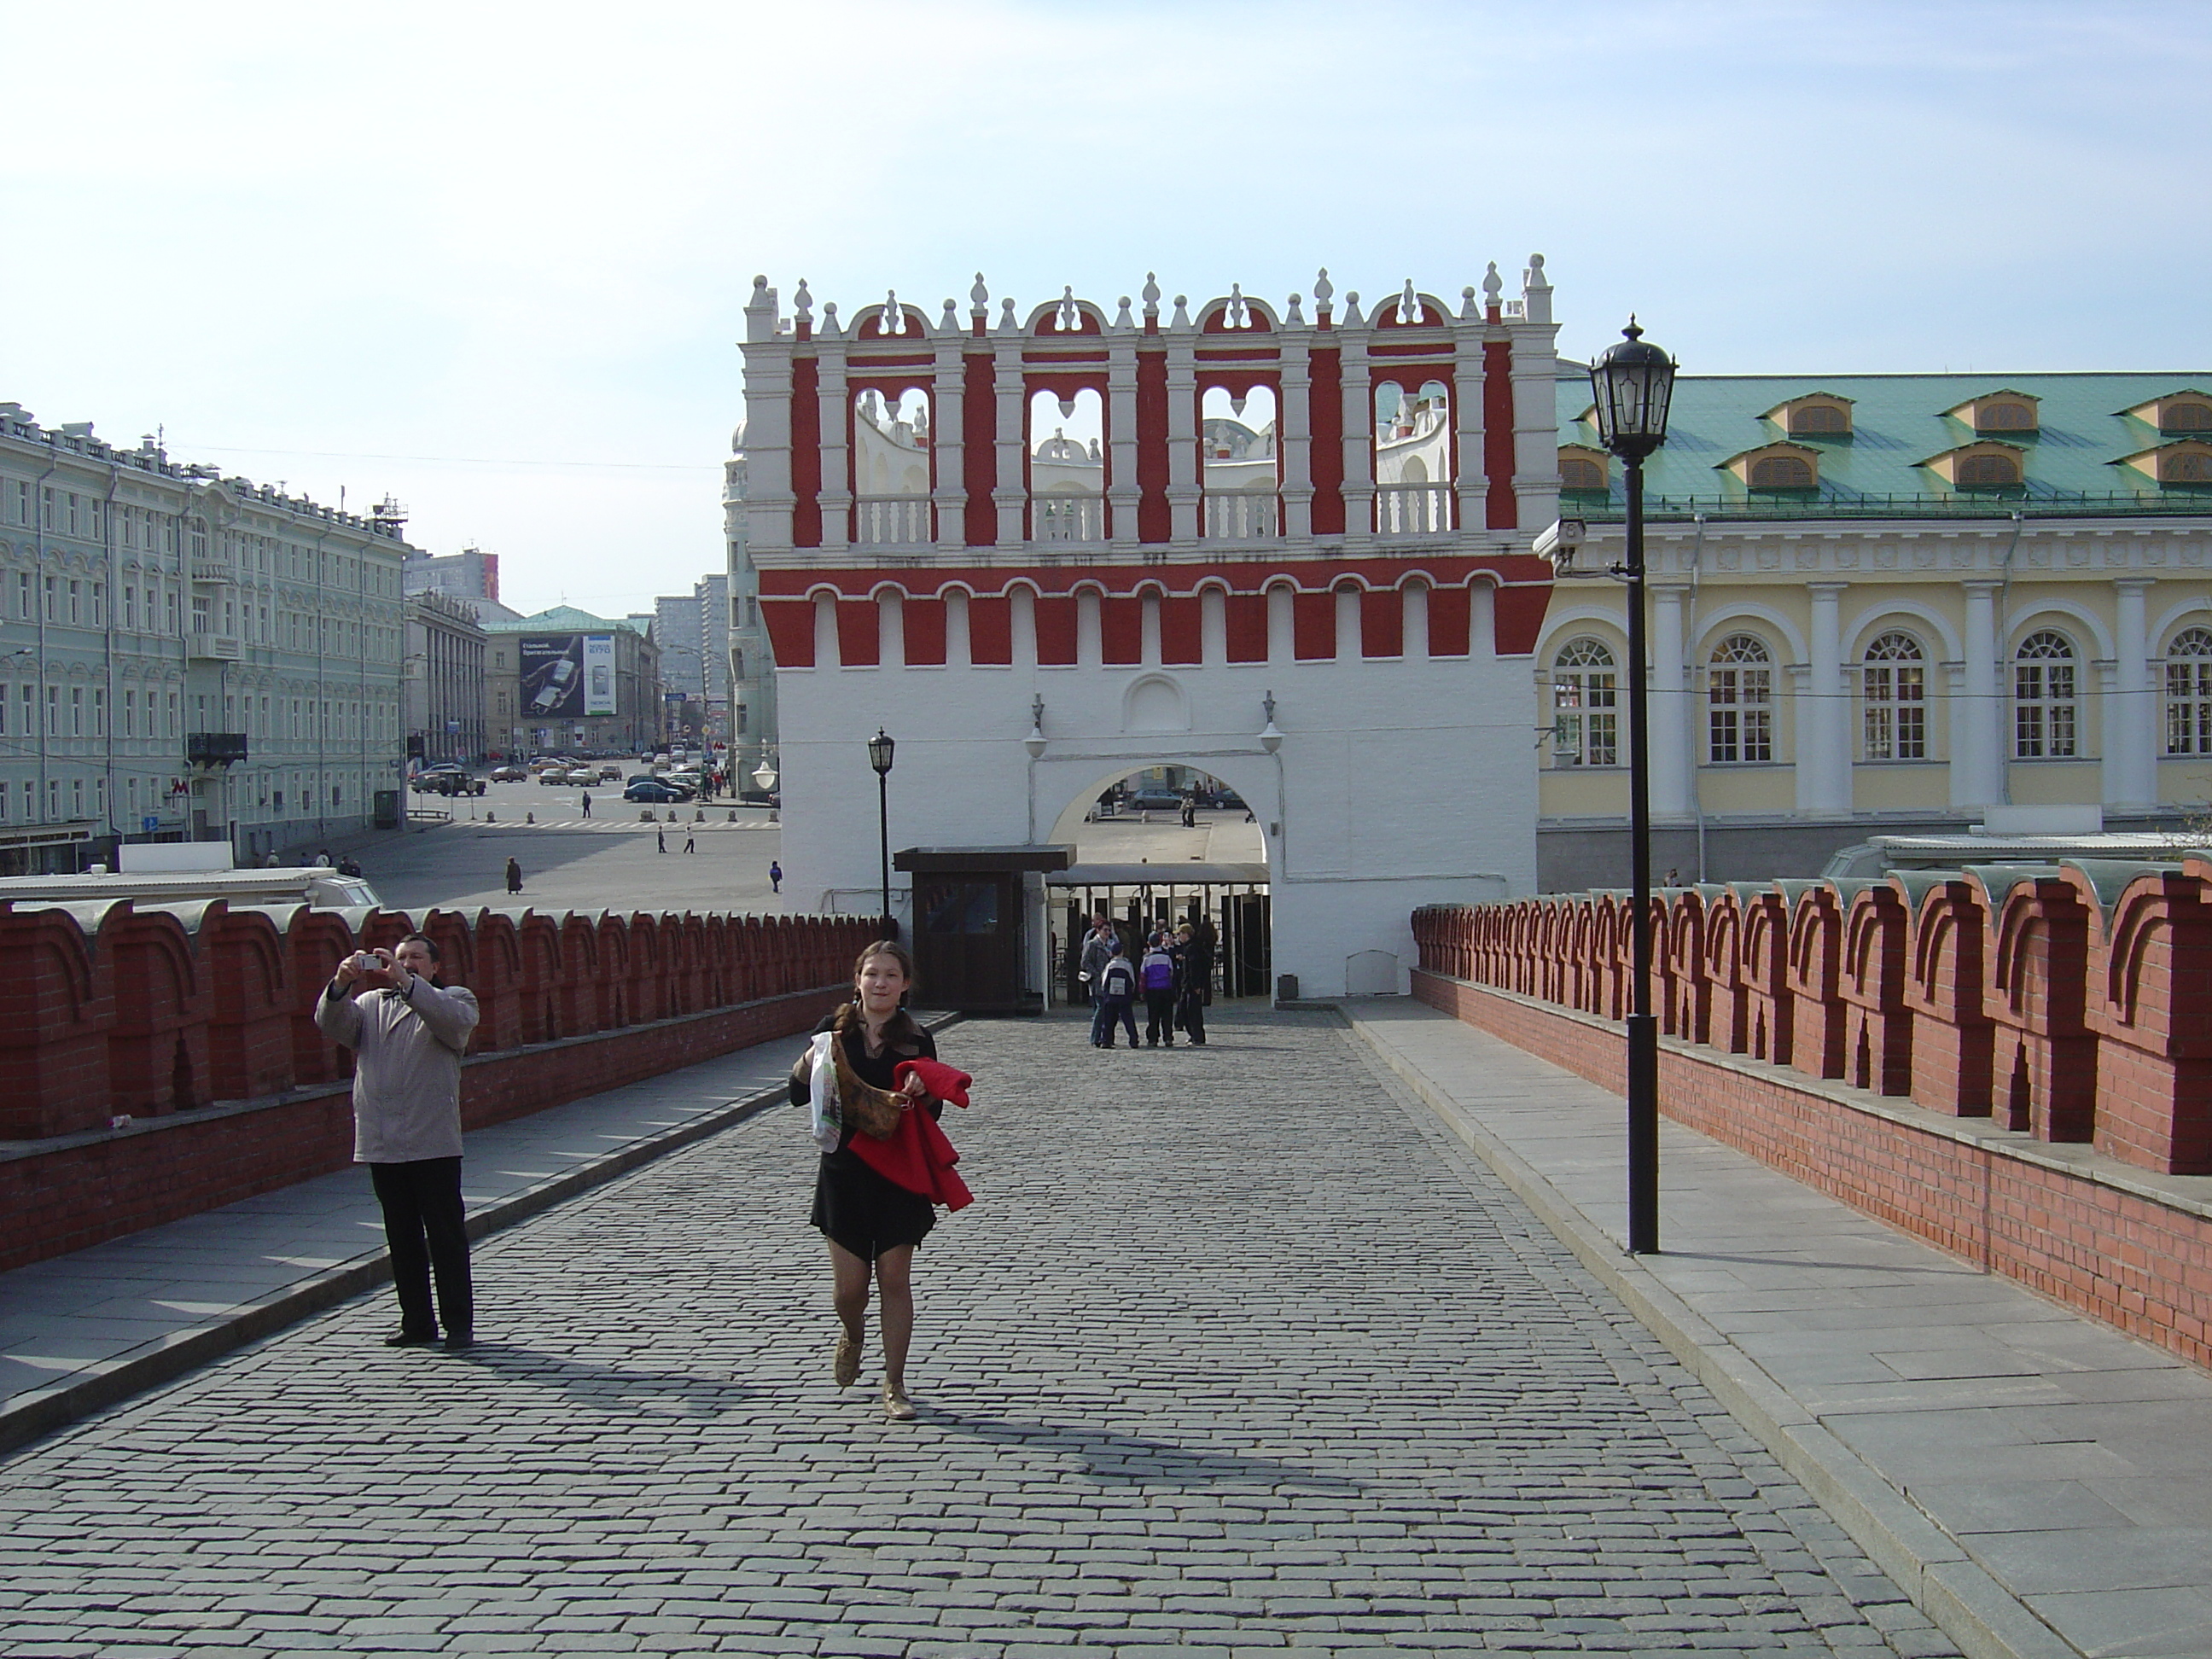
[[1338, 1009, 2081, 1659]]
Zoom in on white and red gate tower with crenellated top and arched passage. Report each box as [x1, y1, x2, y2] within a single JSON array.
[[743, 257, 1559, 995]]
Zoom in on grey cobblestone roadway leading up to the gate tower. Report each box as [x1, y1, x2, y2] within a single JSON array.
[[0, 1009, 1953, 1659]]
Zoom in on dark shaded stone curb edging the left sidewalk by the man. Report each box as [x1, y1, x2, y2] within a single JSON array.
[[0, 1013, 960, 1456]]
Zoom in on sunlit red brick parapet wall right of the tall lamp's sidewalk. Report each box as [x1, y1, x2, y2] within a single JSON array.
[[1413, 859, 2212, 1365]]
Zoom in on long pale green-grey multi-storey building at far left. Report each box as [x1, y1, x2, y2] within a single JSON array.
[[0, 403, 411, 874]]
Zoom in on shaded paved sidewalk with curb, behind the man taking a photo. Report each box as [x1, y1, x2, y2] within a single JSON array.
[[0, 1038, 831, 1451]]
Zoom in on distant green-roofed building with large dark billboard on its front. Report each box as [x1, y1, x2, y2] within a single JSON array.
[[485, 606, 664, 759]]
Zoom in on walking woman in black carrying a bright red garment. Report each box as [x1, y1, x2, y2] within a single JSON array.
[[789, 940, 969, 1423]]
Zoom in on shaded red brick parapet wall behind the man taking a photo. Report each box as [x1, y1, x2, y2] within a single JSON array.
[[0, 900, 878, 1270]]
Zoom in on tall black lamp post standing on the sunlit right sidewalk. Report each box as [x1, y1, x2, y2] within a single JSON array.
[[1591, 317, 1674, 1256]]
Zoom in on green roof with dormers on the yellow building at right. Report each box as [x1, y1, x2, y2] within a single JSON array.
[[1557, 370, 2212, 520]]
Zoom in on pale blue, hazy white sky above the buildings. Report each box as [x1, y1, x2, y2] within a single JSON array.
[[0, 0, 2212, 615]]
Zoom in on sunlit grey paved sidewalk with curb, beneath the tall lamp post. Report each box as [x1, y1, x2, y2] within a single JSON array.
[[1345, 1000, 2212, 1659]]
